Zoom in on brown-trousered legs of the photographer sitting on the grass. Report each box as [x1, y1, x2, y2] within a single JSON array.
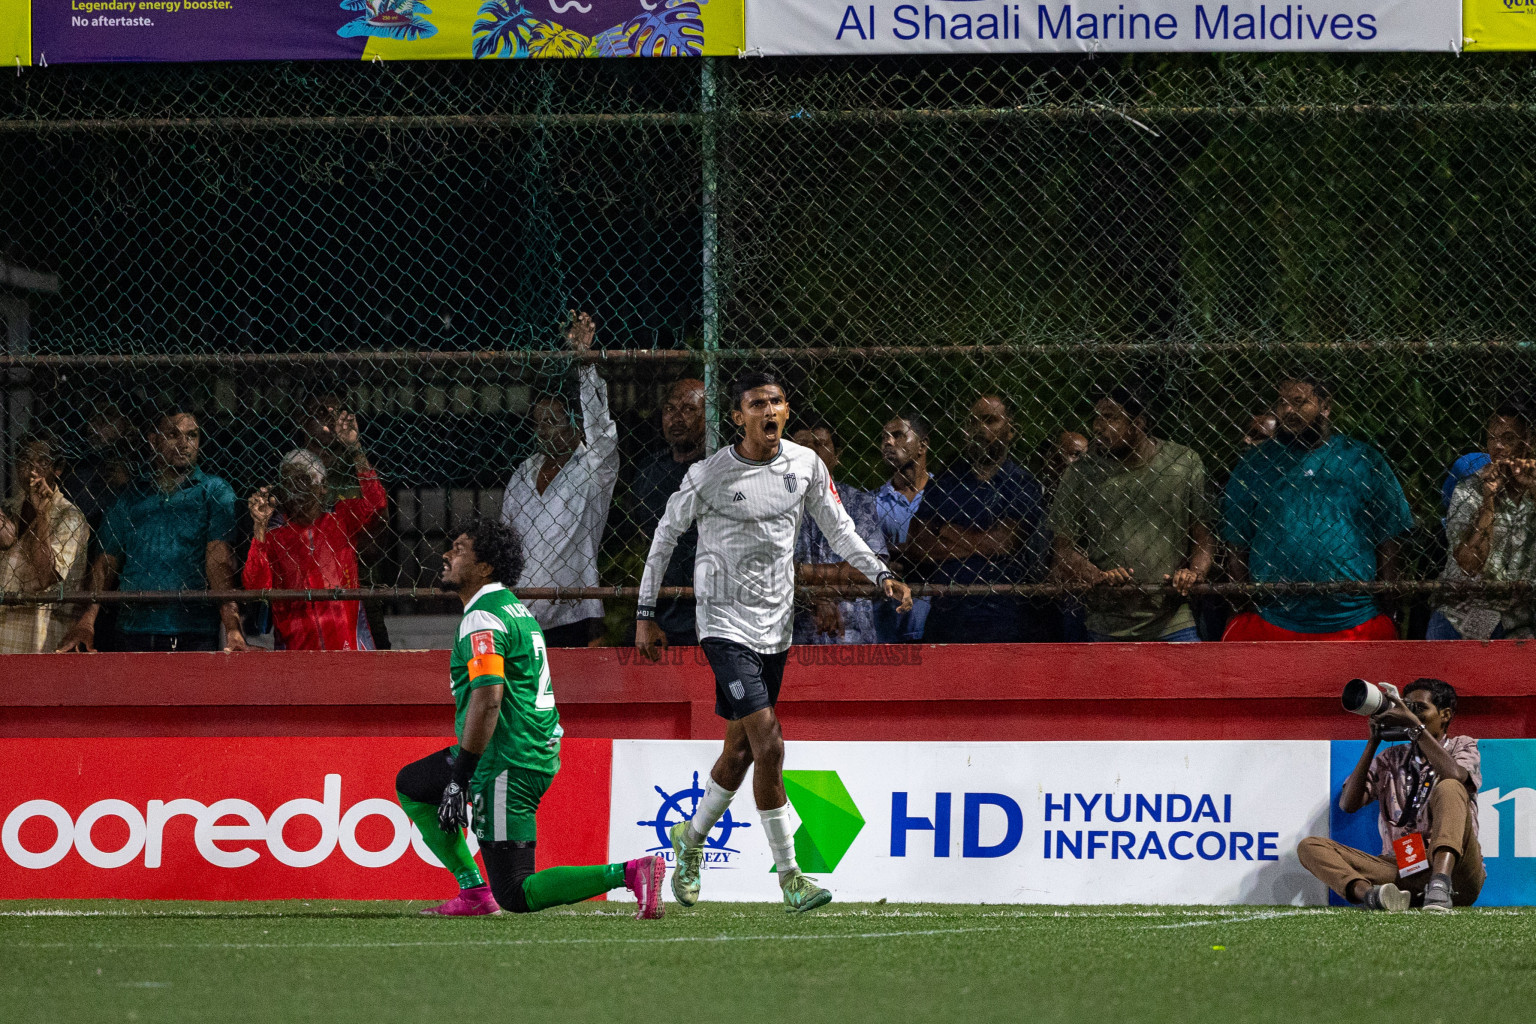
[[1296, 780, 1488, 907]]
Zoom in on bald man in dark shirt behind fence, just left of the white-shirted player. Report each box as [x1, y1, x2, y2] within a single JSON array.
[[634, 378, 703, 646]]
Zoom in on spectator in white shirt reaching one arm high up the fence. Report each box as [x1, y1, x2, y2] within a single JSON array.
[[501, 313, 619, 646]]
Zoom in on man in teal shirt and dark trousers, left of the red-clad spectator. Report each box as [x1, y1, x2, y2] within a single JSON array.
[[58, 411, 247, 651]]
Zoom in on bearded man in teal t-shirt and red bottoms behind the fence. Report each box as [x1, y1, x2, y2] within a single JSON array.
[[1221, 375, 1413, 640]]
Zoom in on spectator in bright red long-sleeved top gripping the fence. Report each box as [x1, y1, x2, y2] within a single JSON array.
[[243, 413, 384, 651]]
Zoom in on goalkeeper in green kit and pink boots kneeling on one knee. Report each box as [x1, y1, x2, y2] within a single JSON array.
[[395, 519, 667, 920]]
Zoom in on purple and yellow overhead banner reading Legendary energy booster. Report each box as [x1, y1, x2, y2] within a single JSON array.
[[12, 0, 742, 64]]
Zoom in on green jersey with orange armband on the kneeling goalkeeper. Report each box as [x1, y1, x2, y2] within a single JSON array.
[[449, 583, 564, 776]]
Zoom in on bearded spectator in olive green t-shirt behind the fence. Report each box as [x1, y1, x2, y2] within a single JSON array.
[[1051, 387, 1215, 643]]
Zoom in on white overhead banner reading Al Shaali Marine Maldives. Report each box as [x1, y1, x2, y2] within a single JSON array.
[[746, 0, 1461, 57]]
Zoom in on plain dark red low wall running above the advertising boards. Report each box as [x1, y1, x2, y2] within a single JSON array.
[[0, 640, 1536, 742]]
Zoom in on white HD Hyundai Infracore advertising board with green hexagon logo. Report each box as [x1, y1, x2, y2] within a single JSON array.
[[608, 740, 1329, 904]]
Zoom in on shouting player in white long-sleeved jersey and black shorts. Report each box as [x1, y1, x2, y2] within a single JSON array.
[[634, 373, 912, 913]]
